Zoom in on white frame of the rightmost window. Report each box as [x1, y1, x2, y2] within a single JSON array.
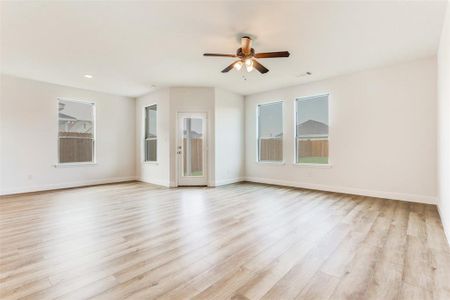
[[292, 92, 332, 168]]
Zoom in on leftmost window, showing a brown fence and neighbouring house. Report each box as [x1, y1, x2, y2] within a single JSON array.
[[58, 99, 95, 164]]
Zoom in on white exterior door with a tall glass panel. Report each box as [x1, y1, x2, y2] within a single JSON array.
[[177, 113, 208, 185]]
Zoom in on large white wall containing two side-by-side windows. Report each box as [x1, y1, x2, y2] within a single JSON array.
[[246, 58, 437, 203]]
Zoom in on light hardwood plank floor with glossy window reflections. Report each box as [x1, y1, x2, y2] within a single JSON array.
[[0, 182, 450, 300]]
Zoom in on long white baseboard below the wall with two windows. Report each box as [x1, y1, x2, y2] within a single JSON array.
[[245, 177, 437, 204]]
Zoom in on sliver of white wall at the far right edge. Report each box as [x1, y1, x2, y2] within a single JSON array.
[[438, 4, 450, 242]]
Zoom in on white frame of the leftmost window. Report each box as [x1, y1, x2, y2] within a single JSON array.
[[55, 97, 97, 167]]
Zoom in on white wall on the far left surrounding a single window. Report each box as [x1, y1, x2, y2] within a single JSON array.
[[0, 75, 135, 194]]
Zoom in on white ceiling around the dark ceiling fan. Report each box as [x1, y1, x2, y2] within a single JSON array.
[[1, 1, 446, 96]]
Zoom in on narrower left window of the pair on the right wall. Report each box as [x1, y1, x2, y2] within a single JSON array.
[[258, 102, 283, 162]]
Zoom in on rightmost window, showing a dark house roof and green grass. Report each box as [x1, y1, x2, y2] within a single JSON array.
[[295, 95, 328, 164]]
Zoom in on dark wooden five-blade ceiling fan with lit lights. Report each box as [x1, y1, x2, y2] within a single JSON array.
[[203, 36, 289, 74]]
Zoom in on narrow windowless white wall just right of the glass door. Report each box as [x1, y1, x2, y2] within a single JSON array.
[[214, 88, 245, 186]]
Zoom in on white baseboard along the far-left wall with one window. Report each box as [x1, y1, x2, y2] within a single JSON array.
[[0, 176, 136, 196]]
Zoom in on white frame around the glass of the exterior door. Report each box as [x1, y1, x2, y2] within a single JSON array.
[[175, 111, 210, 187]]
